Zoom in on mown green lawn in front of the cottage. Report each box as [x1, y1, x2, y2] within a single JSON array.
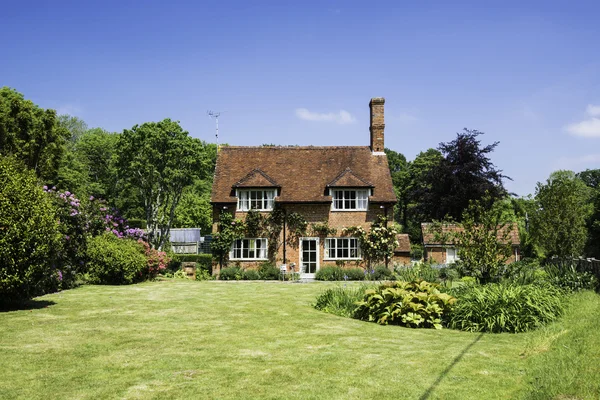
[[0, 280, 600, 400]]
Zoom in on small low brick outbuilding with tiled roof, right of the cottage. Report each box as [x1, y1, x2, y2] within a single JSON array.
[[421, 223, 521, 264]]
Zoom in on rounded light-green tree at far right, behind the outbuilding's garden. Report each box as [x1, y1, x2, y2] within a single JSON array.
[[531, 171, 593, 257]]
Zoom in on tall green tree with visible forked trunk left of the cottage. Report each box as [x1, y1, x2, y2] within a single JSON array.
[[117, 119, 210, 250]]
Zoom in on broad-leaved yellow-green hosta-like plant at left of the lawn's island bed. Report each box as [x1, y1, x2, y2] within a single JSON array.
[[355, 281, 456, 329]]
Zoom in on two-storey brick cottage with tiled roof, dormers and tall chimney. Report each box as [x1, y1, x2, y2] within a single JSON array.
[[211, 98, 406, 278]]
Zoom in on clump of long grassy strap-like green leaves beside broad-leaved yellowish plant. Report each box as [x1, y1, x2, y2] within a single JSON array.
[[449, 283, 563, 333]]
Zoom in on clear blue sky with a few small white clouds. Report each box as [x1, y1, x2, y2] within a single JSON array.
[[0, 0, 600, 195]]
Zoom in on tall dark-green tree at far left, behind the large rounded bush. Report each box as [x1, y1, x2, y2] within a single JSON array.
[[0, 87, 71, 181]]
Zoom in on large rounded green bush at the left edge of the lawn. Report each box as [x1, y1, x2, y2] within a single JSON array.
[[0, 157, 62, 303]]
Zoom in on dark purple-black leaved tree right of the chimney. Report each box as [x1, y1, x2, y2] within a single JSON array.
[[423, 128, 510, 221]]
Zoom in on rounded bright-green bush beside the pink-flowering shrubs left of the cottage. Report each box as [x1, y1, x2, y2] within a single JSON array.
[[86, 232, 149, 285]]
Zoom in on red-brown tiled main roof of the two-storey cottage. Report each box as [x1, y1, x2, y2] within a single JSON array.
[[211, 146, 396, 203]]
